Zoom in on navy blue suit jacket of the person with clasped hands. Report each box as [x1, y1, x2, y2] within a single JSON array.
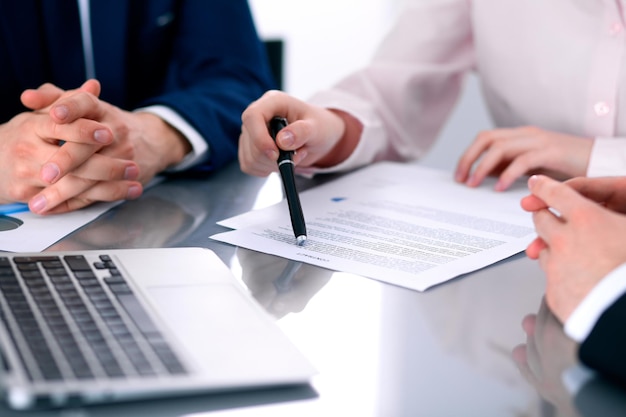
[[0, 0, 274, 170]]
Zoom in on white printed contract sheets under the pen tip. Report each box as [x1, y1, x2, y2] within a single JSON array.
[[211, 162, 535, 291]]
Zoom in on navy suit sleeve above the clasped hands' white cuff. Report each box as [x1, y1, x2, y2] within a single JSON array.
[[131, 0, 274, 171]]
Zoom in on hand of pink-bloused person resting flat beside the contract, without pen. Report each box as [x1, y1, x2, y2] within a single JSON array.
[[455, 126, 593, 191]]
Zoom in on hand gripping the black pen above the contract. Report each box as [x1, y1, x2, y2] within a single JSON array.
[[239, 91, 362, 176]]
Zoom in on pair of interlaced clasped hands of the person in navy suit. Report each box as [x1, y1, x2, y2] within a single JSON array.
[[0, 80, 187, 214]]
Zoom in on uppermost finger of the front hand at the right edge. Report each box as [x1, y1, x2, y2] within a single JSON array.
[[528, 175, 592, 219]]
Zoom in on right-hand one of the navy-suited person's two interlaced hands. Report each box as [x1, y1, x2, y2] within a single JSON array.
[[21, 80, 190, 213]]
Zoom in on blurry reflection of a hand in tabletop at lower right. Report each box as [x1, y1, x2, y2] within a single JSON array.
[[512, 303, 577, 416]]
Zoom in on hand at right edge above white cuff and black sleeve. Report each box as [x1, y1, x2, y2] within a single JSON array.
[[522, 175, 626, 322]]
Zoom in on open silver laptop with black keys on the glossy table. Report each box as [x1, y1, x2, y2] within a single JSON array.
[[0, 248, 316, 409]]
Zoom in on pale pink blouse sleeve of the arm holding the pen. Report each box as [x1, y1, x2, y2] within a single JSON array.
[[298, 0, 474, 175]]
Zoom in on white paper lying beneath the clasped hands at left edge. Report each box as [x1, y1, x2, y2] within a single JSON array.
[[0, 202, 120, 252]]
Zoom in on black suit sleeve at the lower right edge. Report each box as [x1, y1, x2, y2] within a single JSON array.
[[579, 294, 626, 386]]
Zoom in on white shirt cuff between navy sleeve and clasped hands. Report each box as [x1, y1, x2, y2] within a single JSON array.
[[135, 105, 209, 172]]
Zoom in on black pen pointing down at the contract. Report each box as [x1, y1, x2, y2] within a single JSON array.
[[269, 117, 306, 246]]
